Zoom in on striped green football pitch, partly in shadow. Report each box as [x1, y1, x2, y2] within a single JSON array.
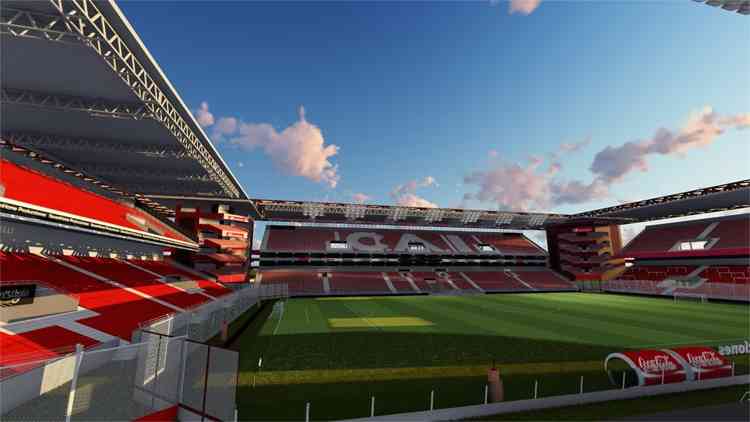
[[232, 293, 750, 420]]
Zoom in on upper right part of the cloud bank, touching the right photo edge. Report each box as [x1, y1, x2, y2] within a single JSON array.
[[590, 107, 750, 184]]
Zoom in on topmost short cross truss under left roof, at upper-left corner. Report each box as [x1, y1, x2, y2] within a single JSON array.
[[0, 7, 83, 45]]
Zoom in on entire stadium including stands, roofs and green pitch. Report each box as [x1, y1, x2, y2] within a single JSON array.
[[0, 0, 750, 421]]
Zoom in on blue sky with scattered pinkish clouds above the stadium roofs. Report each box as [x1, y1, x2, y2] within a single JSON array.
[[120, 1, 750, 223]]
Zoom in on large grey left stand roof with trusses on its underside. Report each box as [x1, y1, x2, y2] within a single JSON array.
[[0, 0, 247, 198]]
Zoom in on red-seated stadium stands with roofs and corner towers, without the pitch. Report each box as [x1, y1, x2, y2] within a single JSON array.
[[0, 0, 750, 419]]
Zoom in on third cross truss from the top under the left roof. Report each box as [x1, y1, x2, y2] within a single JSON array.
[[3, 132, 192, 160]]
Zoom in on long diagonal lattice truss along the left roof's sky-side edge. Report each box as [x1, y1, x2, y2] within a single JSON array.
[[50, 0, 241, 198]]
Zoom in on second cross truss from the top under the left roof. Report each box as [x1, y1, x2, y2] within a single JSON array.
[[0, 88, 153, 120]]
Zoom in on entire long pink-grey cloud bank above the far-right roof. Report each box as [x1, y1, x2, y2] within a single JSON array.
[[462, 107, 750, 210]]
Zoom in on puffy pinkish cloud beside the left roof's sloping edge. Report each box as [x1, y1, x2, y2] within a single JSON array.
[[196, 102, 341, 188]]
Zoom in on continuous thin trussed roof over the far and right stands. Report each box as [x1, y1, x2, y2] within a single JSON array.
[[145, 179, 750, 230]]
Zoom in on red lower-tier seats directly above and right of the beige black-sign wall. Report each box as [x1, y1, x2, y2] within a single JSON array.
[[0, 252, 174, 341]]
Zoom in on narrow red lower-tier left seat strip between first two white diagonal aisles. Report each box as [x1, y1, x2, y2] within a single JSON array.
[[56, 256, 210, 310]]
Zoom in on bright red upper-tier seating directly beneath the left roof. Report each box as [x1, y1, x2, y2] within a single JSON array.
[[0, 160, 189, 241]]
